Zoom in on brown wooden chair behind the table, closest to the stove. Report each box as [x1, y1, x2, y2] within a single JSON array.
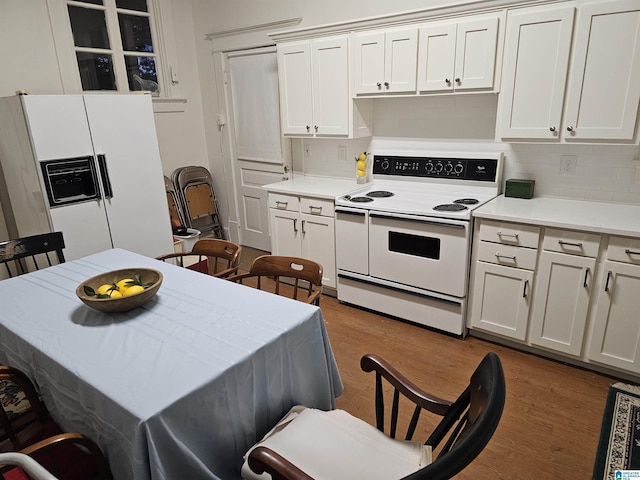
[[227, 255, 322, 305]]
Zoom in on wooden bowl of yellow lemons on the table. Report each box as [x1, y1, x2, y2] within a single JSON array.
[[76, 268, 162, 313]]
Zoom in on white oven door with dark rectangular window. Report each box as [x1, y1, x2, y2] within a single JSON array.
[[369, 211, 470, 298]]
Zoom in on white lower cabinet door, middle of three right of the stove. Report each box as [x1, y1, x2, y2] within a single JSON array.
[[530, 251, 596, 355]]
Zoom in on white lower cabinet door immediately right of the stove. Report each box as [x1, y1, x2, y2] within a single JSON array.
[[470, 262, 533, 340]]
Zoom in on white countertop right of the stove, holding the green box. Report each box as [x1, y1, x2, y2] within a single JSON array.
[[473, 195, 640, 238]]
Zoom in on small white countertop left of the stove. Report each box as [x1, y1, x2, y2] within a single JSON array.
[[262, 174, 366, 200]]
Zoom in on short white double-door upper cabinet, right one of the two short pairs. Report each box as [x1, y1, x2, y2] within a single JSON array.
[[418, 15, 499, 93]]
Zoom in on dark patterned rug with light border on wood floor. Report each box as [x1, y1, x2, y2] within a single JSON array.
[[593, 383, 640, 480]]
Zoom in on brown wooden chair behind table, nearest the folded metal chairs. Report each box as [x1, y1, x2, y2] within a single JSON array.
[[156, 238, 242, 278]]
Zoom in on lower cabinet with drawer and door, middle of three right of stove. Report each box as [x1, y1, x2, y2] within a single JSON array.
[[529, 229, 600, 356]]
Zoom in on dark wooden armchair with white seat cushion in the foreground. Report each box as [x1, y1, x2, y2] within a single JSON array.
[[242, 353, 506, 480]]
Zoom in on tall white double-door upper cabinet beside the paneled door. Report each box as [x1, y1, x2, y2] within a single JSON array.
[[277, 35, 373, 138]]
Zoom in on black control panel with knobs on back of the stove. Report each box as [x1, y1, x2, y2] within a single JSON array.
[[373, 155, 498, 182]]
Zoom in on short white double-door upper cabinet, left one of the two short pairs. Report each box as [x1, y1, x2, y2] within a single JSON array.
[[353, 28, 418, 95]]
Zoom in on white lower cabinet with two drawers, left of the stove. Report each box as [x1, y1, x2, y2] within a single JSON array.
[[269, 194, 336, 288]]
